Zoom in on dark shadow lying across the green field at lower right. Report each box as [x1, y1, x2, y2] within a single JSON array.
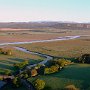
[[52, 65, 90, 80]]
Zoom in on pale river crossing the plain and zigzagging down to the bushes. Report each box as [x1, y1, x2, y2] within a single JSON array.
[[0, 35, 90, 68]]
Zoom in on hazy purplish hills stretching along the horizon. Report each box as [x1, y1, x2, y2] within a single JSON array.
[[0, 22, 90, 30]]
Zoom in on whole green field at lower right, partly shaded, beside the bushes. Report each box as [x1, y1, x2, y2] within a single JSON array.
[[29, 64, 90, 90]]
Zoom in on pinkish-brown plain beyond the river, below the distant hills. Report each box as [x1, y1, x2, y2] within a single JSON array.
[[0, 29, 90, 43]]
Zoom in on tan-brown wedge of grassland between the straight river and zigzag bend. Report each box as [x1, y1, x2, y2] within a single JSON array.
[[16, 37, 90, 58]]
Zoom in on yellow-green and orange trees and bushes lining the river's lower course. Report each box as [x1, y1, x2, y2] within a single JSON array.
[[13, 59, 72, 90]]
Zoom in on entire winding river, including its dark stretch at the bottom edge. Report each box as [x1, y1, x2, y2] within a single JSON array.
[[0, 35, 90, 90]]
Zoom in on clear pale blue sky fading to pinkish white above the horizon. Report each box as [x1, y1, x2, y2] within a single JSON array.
[[0, 0, 90, 22]]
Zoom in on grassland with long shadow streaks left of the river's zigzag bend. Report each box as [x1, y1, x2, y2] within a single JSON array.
[[0, 49, 44, 74]]
